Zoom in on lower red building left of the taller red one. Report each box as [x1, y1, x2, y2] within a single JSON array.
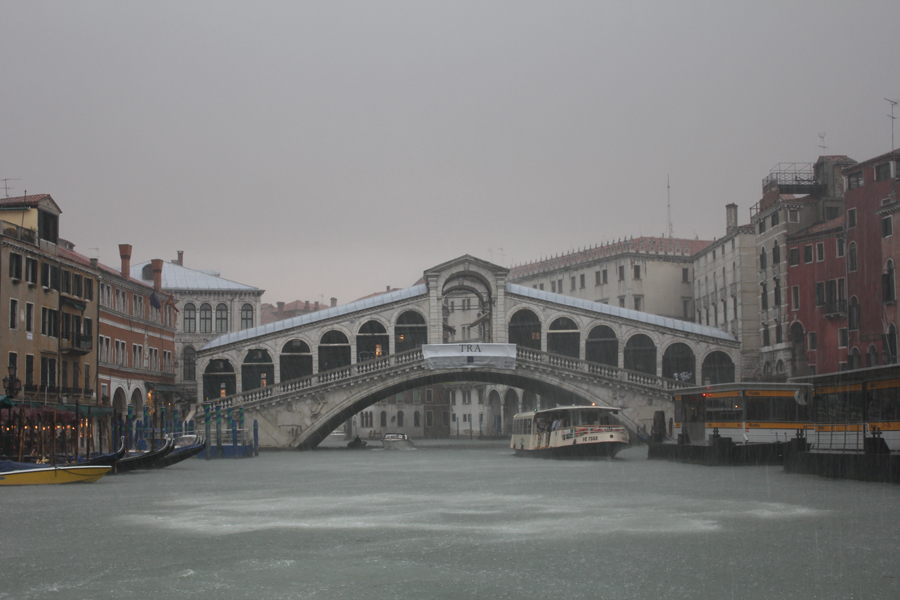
[[785, 216, 858, 375]]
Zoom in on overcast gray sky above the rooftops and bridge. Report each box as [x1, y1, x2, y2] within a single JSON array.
[[0, 0, 900, 304]]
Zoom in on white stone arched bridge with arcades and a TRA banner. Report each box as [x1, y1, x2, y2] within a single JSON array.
[[196, 255, 740, 448]]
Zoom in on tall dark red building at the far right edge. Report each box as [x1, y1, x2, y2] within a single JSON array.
[[844, 150, 900, 368]]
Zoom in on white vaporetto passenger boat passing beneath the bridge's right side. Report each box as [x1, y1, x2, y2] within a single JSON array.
[[510, 405, 631, 458]]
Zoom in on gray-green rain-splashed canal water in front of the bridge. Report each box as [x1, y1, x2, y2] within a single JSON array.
[[0, 443, 900, 600]]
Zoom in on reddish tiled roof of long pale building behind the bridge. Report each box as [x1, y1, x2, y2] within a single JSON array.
[[509, 236, 712, 280]]
